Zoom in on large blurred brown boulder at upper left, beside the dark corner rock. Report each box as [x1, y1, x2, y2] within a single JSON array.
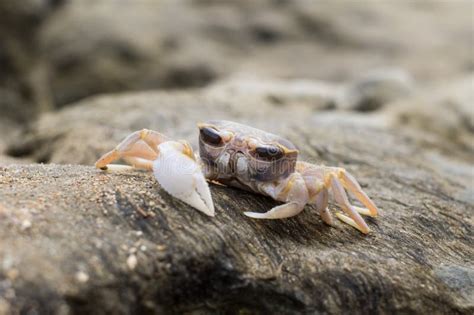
[[40, 1, 218, 106]]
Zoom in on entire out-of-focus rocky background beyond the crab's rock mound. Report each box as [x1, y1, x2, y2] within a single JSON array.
[[0, 0, 474, 167]]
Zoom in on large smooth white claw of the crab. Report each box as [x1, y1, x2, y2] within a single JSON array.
[[153, 141, 214, 216]]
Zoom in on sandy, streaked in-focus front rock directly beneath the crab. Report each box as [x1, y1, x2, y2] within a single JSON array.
[[0, 152, 473, 314]]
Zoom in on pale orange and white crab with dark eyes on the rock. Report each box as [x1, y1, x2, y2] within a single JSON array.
[[95, 120, 378, 234]]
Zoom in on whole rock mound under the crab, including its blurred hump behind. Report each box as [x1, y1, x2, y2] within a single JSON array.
[[0, 86, 474, 314]]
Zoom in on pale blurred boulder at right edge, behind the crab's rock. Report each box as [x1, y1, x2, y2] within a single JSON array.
[[387, 74, 474, 160]]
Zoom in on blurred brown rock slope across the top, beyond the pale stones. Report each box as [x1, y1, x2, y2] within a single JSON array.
[[0, 0, 474, 121]]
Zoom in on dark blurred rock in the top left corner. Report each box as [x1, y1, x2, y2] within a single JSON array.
[[0, 0, 62, 122]]
